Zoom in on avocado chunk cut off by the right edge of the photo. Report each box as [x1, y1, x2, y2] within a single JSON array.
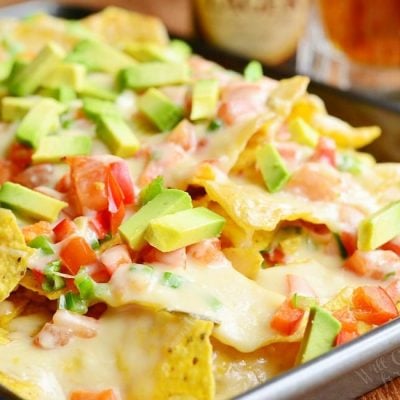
[[357, 201, 400, 251]]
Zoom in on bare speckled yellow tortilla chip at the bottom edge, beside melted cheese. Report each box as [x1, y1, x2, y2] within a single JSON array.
[[154, 318, 215, 400]]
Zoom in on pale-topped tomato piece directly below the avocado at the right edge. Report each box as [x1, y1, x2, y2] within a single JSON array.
[[343, 250, 400, 280]]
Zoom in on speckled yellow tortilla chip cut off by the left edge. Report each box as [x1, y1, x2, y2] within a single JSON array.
[[0, 208, 32, 301]]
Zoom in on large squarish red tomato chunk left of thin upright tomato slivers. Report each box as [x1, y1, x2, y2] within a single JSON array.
[[67, 157, 108, 215]]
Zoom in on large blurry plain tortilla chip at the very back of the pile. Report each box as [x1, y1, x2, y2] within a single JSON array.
[[82, 7, 168, 48]]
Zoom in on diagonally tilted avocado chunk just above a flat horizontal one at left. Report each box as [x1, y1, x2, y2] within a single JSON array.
[[17, 98, 64, 149]]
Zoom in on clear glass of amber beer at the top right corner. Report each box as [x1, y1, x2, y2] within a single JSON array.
[[297, 0, 400, 94]]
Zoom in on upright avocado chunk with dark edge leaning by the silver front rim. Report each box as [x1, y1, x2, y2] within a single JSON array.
[[297, 306, 341, 364]]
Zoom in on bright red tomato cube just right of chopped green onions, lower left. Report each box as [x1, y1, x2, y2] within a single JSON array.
[[60, 236, 97, 275]]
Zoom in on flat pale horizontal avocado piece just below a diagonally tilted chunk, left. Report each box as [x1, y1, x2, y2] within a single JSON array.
[[32, 135, 92, 163]]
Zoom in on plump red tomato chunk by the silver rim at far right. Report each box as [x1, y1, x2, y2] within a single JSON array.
[[352, 286, 398, 325]]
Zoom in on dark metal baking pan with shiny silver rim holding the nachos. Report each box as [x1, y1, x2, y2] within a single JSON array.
[[0, 1, 400, 400]]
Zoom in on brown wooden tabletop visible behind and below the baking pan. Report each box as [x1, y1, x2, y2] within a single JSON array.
[[0, 0, 400, 400]]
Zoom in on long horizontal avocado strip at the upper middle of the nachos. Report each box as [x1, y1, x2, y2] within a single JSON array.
[[120, 62, 190, 89]]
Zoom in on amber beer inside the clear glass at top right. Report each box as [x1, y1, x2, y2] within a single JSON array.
[[319, 0, 400, 67]]
